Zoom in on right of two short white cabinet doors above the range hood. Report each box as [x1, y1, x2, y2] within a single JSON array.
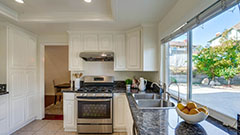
[[99, 34, 113, 51]]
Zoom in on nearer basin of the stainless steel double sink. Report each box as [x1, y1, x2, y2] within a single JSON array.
[[136, 99, 175, 109]]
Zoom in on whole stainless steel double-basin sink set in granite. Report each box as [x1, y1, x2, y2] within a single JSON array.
[[132, 93, 175, 110]]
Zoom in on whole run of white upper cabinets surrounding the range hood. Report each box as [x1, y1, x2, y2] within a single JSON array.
[[67, 25, 158, 71]]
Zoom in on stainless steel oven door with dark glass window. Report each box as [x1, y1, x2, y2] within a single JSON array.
[[77, 98, 112, 124]]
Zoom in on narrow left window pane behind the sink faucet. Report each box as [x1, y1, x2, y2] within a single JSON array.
[[168, 33, 187, 99]]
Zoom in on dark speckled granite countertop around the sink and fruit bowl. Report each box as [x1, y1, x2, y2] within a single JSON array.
[[127, 93, 236, 135]]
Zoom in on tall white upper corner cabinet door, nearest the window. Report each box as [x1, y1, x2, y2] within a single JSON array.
[[127, 31, 141, 71]]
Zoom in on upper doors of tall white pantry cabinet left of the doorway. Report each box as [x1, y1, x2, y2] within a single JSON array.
[[7, 27, 37, 68]]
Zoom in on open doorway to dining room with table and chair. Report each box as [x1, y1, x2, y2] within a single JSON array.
[[44, 45, 70, 120]]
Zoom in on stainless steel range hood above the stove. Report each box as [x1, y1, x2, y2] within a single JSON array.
[[79, 52, 114, 61]]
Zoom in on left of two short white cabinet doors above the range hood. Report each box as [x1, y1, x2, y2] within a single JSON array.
[[83, 34, 98, 52]]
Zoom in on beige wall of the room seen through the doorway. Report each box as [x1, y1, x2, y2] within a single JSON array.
[[44, 46, 70, 95]]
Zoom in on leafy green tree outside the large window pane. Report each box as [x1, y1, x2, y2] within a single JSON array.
[[193, 31, 240, 84]]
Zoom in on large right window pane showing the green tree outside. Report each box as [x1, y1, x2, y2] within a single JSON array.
[[192, 6, 240, 118]]
